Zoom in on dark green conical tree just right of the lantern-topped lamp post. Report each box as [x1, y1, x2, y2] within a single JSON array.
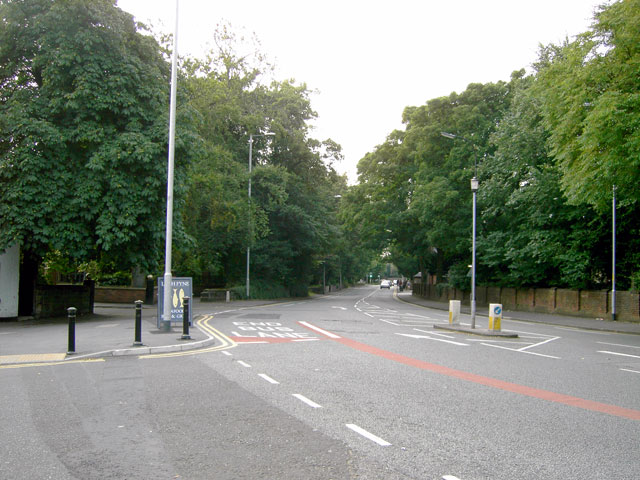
[[478, 71, 605, 288]]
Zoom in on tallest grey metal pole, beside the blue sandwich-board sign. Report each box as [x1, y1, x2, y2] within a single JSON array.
[[162, 0, 179, 330]]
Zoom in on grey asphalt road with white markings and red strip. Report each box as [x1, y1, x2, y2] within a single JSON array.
[[0, 287, 640, 480]]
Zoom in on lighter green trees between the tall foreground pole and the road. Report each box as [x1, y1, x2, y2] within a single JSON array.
[[178, 27, 346, 295]]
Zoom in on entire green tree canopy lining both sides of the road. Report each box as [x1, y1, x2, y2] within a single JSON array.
[[0, 0, 640, 296]]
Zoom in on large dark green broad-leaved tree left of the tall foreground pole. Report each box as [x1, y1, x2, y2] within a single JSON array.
[[0, 0, 194, 268]]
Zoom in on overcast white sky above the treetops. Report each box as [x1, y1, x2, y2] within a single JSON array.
[[118, 0, 608, 183]]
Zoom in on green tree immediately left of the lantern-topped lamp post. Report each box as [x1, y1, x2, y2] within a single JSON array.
[[403, 82, 512, 280]]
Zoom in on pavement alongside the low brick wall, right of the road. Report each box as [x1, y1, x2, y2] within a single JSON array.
[[397, 292, 640, 335]]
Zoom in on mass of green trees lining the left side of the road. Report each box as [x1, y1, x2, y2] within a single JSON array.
[[0, 0, 354, 295]]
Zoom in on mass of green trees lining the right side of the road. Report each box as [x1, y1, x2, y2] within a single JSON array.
[[345, 0, 640, 289]]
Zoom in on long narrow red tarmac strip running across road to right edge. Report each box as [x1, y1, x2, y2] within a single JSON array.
[[302, 322, 640, 420]]
